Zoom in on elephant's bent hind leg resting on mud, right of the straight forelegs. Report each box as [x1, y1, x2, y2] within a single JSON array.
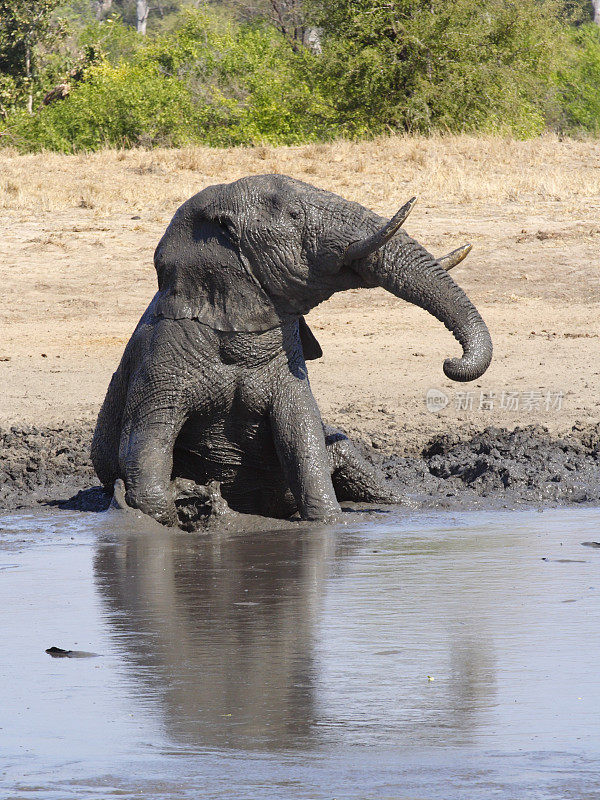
[[323, 425, 402, 503]]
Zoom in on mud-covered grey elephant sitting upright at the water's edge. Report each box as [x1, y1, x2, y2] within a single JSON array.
[[91, 175, 492, 526]]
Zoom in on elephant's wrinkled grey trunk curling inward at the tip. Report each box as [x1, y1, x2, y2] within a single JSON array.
[[355, 236, 492, 381]]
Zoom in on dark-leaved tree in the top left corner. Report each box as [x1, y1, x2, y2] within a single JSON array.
[[0, 0, 64, 114]]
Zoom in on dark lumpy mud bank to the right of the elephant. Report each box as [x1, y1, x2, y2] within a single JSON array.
[[369, 425, 600, 507]]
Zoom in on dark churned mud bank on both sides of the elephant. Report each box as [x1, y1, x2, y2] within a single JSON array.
[[0, 423, 600, 511]]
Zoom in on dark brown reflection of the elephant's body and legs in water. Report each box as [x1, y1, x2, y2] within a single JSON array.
[[95, 531, 332, 750]]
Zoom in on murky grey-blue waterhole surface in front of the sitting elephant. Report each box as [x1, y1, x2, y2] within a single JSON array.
[[0, 509, 600, 800]]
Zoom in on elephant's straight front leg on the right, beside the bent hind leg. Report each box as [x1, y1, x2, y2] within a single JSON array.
[[271, 376, 340, 520]]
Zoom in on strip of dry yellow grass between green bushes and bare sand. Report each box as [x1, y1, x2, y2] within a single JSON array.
[[0, 136, 600, 219]]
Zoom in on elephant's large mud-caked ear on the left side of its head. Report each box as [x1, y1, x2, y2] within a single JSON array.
[[153, 187, 286, 332]]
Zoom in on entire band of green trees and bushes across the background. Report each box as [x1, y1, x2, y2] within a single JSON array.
[[0, 0, 600, 152]]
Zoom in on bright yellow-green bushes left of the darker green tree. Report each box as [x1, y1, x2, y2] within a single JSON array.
[[4, 11, 323, 152]]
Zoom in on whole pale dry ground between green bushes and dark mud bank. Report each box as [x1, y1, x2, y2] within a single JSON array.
[[0, 137, 600, 452]]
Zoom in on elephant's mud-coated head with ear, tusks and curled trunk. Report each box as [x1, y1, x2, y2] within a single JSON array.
[[153, 175, 492, 381]]
